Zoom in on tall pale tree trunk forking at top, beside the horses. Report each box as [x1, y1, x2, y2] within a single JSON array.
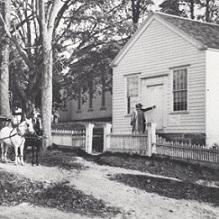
[[39, 0, 64, 150]]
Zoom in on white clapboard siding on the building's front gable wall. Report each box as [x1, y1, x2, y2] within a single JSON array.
[[113, 20, 205, 133]]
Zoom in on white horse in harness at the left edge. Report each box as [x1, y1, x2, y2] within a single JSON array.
[[0, 119, 35, 165]]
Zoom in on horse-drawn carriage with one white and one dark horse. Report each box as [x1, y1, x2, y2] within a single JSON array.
[[0, 115, 42, 165]]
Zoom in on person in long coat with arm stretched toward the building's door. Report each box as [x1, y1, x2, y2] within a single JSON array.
[[131, 103, 156, 133]]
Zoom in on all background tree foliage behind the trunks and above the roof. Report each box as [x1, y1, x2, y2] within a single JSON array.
[[0, 0, 219, 115]]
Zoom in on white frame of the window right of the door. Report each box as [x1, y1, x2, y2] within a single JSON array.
[[171, 66, 189, 113]]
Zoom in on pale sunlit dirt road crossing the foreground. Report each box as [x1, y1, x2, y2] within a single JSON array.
[[0, 157, 219, 219]]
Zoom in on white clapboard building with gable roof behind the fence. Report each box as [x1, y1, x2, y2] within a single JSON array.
[[112, 13, 219, 146]]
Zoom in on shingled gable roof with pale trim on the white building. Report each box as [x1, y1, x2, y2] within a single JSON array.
[[111, 12, 219, 66]]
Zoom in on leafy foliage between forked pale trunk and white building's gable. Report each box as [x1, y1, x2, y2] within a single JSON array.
[[57, 0, 152, 101]]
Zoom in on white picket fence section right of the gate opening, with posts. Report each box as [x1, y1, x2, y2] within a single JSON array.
[[104, 123, 219, 163]]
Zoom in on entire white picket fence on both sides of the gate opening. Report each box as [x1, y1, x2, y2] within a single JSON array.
[[52, 123, 219, 163]]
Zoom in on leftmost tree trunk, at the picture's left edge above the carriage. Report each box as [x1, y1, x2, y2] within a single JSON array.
[[0, 0, 11, 117]]
